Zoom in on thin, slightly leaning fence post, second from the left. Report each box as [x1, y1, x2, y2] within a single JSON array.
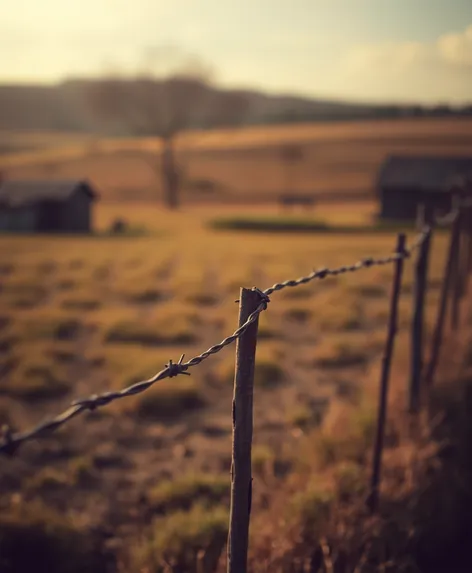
[[367, 234, 405, 513]]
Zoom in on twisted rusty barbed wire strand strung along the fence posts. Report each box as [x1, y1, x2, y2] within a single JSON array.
[[0, 201, 459, 456]]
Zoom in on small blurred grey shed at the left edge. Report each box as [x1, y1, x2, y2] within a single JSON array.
[[0, 180, 98, 233]]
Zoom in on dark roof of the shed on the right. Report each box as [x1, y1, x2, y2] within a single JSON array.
[[378, 155, 472, 191]]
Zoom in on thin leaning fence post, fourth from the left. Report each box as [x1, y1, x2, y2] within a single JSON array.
[[424, 210, 461, 387]]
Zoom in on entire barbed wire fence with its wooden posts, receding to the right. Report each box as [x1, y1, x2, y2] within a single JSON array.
[[0, 182, 472, 573]]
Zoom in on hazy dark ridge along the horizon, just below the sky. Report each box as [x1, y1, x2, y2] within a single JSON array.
[[0, 80, 472, 135]]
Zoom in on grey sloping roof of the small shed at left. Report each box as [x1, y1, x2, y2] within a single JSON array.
[[0, 180, 97, 207]]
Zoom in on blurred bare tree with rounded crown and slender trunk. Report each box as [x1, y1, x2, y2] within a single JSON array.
[[88, 50, 251, 209]]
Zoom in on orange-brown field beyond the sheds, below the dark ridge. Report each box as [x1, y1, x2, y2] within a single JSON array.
[[0, 118, 472, 204]]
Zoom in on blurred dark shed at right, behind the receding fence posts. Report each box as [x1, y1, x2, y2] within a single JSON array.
[[377, 155, 472, 220]]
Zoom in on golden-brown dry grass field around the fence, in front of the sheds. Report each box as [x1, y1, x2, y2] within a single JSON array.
[[0, 118, 472, 573]]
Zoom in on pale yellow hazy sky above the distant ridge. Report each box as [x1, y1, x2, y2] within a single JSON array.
[[0, 0, 472, 104]]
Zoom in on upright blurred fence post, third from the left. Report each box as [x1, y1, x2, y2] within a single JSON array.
[[408, 206, 432, 413]]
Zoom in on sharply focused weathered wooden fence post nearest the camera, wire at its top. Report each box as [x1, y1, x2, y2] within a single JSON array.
[[227, 288, 261, 573]]
